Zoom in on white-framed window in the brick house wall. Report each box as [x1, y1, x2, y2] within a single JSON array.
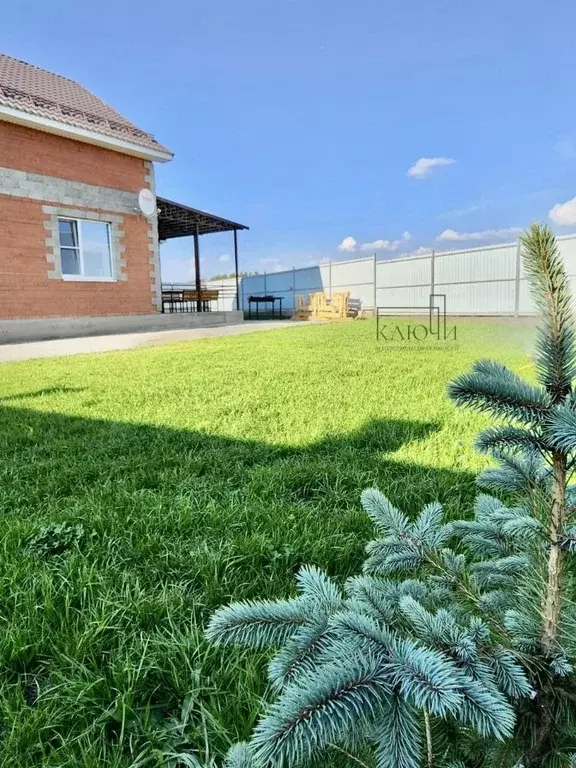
[[58, 219, 114, 280]]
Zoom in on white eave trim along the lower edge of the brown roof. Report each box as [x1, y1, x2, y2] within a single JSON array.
[[0, 104, 174, 163]]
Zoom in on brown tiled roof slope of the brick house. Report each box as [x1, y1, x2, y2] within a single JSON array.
[[0, 53, 170, 158]]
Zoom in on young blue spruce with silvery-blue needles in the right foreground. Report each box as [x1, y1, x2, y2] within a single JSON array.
[[208, 225, 576, 768]]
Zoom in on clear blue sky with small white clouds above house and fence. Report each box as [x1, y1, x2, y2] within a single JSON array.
[[0, 0, 576, 280]]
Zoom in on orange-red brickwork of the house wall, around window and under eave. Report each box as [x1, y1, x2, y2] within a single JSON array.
[[0, 122, 157, 319]]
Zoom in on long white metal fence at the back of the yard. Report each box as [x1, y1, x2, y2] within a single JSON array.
[[207, 235, 576, 316]]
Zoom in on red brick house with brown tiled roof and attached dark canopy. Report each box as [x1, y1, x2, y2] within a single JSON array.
[[0, 54, 245, 340]]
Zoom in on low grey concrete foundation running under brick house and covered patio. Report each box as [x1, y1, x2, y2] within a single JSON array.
[[0, 311, 244, 344]]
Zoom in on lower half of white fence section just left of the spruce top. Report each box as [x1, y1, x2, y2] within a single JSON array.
[[434, 280, 515, 315]]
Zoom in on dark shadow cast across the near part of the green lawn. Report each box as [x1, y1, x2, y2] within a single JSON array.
[[0, 406, 474, 766]]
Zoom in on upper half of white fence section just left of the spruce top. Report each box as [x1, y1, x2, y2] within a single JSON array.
[[434, 245, 516, 283]]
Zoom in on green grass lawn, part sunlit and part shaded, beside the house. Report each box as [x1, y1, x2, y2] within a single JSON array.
[[0, 321, 530, 768]]
